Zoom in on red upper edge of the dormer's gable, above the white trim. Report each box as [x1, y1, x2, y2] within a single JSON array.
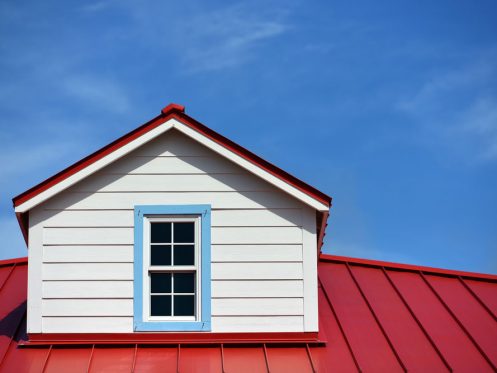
[[12, 104, 331, 207]]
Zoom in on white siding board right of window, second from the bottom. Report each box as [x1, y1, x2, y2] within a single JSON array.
[[212, 298, 304, 316]]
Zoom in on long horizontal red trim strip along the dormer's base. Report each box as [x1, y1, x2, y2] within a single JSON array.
[[25, 332, 326, 346]]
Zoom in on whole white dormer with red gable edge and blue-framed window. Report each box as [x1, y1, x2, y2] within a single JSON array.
[[14, 104, 331, 338]]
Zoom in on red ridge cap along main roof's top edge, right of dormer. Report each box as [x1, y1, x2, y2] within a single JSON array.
[[319, 254, 497, 281]]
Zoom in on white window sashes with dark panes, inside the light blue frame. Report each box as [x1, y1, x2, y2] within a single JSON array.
[[143, 215, 201, 321]]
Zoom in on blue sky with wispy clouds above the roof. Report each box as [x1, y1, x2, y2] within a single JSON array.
[[0, 0, 497, 273]]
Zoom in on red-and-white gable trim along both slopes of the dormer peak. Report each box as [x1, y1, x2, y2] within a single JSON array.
[[13, 104, 331, 213]]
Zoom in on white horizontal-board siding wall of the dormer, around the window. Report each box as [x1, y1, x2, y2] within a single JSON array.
[[28, 130, 318, 333]]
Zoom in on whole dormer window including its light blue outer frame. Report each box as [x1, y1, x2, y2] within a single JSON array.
[[134, 205, 211, 331]]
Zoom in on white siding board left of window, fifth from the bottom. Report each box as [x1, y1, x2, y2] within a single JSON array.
[[43, 245, 133, 263]]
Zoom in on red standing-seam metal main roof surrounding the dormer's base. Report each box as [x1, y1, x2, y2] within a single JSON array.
[[0, 255, 497, 373]]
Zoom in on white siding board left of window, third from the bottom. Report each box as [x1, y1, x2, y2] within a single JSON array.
[[42, 281, 133, 299]]
